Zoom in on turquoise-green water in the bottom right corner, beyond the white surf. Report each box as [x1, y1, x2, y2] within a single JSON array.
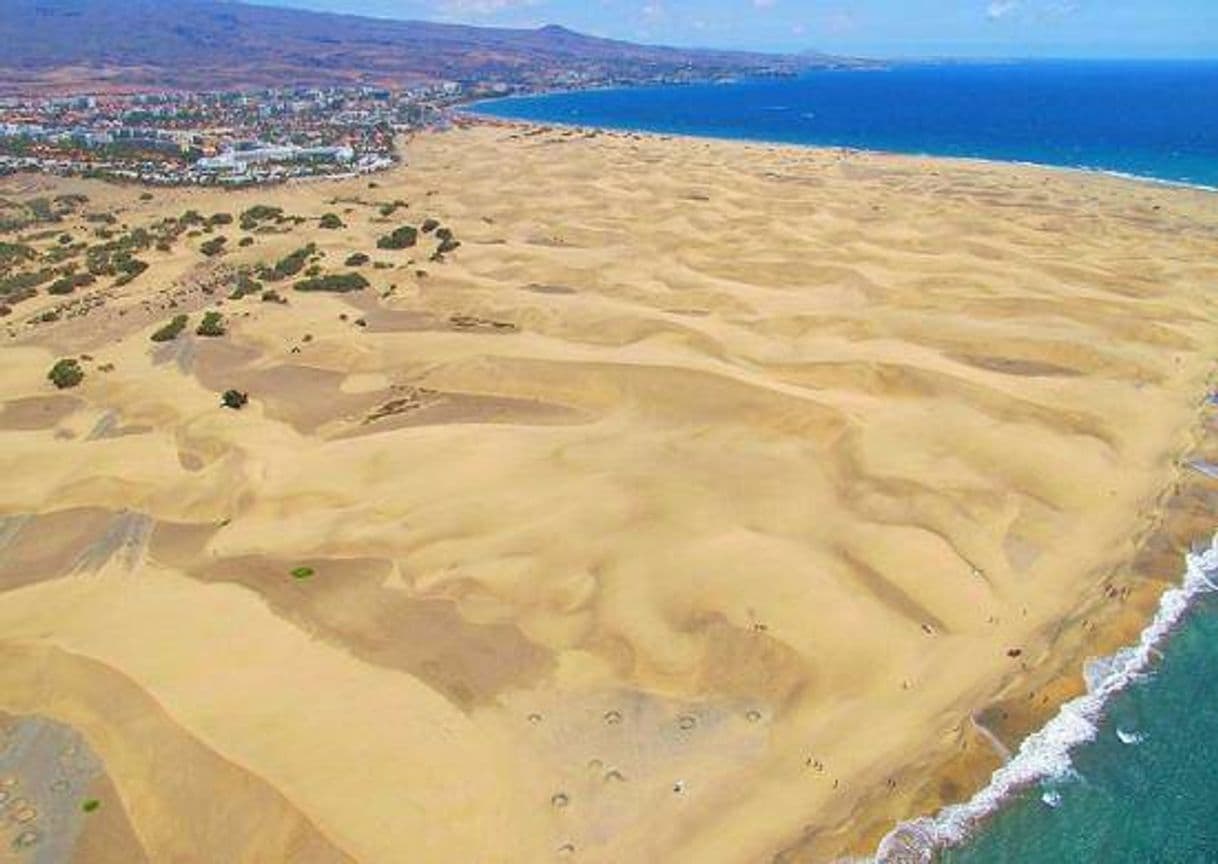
[[944, 598, 1218, 864]]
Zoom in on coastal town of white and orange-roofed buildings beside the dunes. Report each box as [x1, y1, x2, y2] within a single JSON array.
[[0, 82, 487, 186]]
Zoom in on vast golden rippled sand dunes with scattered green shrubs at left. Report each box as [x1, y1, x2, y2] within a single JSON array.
[[0, 124, 1218, 864]]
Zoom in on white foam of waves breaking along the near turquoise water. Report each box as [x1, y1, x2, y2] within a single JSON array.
[[873, 535, 1218, 864]]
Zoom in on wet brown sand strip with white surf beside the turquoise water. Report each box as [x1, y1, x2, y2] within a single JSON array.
[[831, 386, 1218, 864]]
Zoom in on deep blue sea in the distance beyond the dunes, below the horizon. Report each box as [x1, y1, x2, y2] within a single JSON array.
[[475, 60, 1218, 188]]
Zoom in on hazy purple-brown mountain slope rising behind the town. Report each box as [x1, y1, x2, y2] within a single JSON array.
[[0, 0, 834, 93]]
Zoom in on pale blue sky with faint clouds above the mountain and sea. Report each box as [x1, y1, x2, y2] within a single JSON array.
[[244, 0, 1218, 58]]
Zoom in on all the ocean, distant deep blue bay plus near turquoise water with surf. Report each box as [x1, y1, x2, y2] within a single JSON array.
[[471, 62, 1218, 864]]
